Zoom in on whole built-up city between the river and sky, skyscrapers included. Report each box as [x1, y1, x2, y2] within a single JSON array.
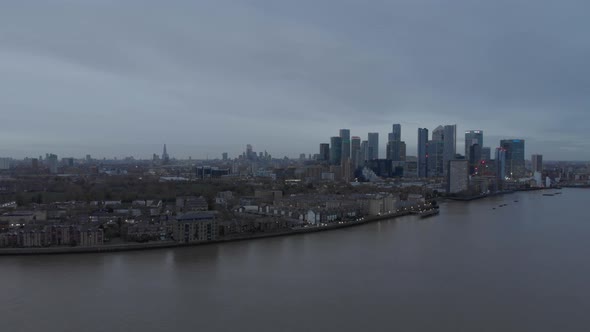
[[0, 124, 590, 250]]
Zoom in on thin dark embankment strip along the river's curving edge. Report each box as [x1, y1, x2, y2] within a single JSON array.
[[0, 212, 410, 256]]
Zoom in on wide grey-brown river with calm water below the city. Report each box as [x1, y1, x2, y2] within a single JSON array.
[[0, 189, 590, 332]]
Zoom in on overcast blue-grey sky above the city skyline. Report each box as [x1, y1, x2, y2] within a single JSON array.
[[0, 0, 590, 160]]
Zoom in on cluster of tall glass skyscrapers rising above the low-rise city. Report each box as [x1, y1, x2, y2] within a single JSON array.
[[317, 124, 542, 184]]
